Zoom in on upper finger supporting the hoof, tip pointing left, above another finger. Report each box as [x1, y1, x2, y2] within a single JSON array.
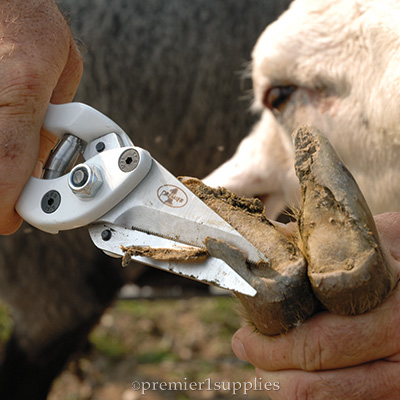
[[232, 290, 400, 371]]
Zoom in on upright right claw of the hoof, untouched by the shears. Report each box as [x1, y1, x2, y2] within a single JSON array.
[[293, 126, 396, 315]]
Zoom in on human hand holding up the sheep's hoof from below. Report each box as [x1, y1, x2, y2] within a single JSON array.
[[232, 213, 400, 400]]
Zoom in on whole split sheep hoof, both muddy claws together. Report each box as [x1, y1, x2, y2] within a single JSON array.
[[182, 126, 396, 335]]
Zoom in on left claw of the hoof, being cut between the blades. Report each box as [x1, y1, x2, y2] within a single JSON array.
[[180, 178, 316, 335]]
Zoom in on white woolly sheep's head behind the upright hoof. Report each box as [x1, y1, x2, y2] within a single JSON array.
[[206, 0, 400, 217]]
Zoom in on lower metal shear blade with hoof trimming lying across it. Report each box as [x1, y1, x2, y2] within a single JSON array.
[[89, 224, 257, 296]]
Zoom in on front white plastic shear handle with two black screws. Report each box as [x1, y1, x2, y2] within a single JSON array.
[[16, 147, 152, 233]]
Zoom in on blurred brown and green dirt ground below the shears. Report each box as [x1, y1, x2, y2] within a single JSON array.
[[0, 297, 276, 400]]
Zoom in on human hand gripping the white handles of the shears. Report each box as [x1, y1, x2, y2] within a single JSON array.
[[0, 0, 82, 234]]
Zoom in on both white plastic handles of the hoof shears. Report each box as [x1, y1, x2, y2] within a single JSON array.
[[16, 103, 152, 233]]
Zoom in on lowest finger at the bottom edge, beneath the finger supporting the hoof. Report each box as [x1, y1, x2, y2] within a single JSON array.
[[256, 360, 400, 400]]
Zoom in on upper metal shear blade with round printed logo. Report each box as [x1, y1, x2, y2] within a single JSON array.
[[97, 159, 268, 263]]
